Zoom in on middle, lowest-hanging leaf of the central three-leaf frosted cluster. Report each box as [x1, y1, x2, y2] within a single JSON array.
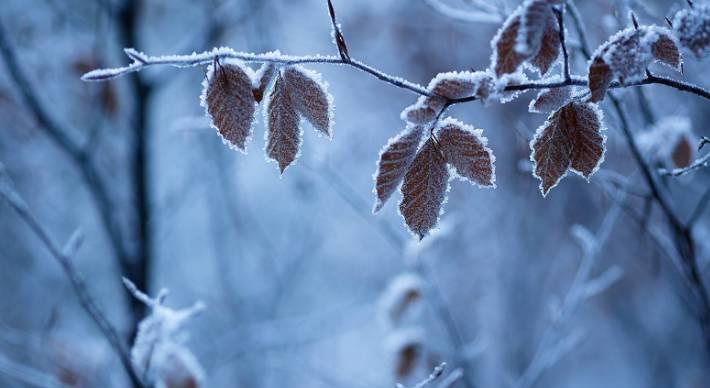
[[399, 139, 449, 240]]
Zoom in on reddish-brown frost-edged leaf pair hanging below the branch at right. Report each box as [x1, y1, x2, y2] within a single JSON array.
[[530, 102, 606, 196]]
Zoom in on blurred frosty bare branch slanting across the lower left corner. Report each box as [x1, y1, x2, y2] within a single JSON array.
[[0, 164, 143, 388]]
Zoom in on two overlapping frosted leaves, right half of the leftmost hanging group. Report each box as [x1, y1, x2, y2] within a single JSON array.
[[265, 67, 333, 174]]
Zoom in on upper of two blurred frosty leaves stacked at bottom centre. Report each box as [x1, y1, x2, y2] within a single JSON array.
[[378, 272, 424, 327]]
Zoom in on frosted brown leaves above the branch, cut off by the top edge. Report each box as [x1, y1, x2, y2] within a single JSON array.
[[491, 0, 561, 77]]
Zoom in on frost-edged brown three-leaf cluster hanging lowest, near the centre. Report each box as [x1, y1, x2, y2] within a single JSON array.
[[374, 118, 495, 239]]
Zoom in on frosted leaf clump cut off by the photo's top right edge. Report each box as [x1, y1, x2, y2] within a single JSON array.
[[673, 4, 710, 59]]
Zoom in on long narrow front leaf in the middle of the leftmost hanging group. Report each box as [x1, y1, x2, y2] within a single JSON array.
[[265, 74, 303, 174]]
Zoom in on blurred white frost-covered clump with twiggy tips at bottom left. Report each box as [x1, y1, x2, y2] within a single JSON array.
[[123, 278, 204, 388]]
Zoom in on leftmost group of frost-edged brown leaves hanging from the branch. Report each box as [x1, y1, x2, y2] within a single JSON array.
[[202, 62, 333, 174]]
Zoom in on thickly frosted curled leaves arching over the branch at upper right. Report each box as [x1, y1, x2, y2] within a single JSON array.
[[588, 26, 682, 102]]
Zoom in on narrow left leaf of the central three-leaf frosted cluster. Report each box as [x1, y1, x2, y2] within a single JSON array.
[[373, 125, 424, 213]]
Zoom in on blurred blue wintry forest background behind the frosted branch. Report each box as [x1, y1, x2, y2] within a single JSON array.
[[0, 0, 710, 388]]
